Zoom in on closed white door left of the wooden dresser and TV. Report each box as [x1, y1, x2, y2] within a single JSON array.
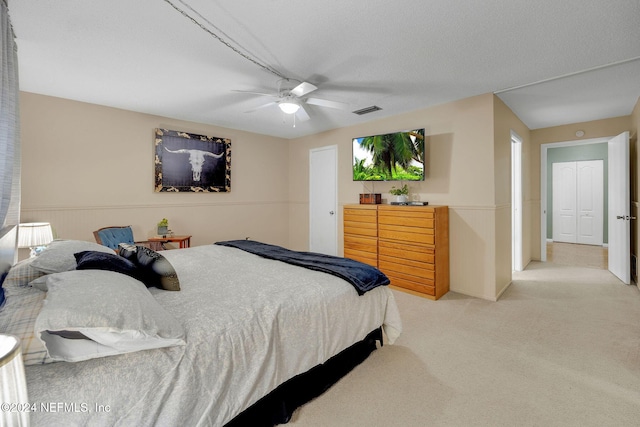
[[309, 145, 338, 255]]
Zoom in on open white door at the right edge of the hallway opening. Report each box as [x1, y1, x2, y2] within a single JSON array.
[[608, 132, 631, 285]]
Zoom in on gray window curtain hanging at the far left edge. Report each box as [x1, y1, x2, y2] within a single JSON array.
[[0, 0, 20, 229]]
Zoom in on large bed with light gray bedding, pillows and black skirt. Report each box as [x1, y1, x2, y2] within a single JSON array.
[[0, 229, 401, 426]]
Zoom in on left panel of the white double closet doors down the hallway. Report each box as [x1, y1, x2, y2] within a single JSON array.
[[552, 162, 577, 243]]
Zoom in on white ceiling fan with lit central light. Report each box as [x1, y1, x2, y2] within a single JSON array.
[[234, 78, 349, 121]]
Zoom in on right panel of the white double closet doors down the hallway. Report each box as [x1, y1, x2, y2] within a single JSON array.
[[576, 160, 604, 245]]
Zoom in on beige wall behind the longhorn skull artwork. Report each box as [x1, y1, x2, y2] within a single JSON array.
[[20, 92, 289, 249]]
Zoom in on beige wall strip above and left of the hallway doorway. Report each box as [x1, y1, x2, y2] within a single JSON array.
[[530, 116, 631, 260]]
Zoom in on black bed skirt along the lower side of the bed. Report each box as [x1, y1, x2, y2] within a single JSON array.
[[225, 328, 382, 427]]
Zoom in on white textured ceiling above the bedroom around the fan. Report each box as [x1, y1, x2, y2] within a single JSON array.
[[9, 0, 640, 138]]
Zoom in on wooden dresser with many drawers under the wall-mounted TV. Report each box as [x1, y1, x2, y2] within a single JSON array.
[[344, 205, 449, 300]]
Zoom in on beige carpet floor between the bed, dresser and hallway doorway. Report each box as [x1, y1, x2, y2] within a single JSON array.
[[289, 263, 640, 427]]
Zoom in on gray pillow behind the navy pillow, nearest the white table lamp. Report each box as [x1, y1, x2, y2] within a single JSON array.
[[31, 240, 114, 274]]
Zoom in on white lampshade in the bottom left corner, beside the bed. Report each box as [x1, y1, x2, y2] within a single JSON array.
[[0, 334, 29, 426]]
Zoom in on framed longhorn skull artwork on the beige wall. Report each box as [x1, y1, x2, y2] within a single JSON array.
[[155, 128, 231, 193]]
